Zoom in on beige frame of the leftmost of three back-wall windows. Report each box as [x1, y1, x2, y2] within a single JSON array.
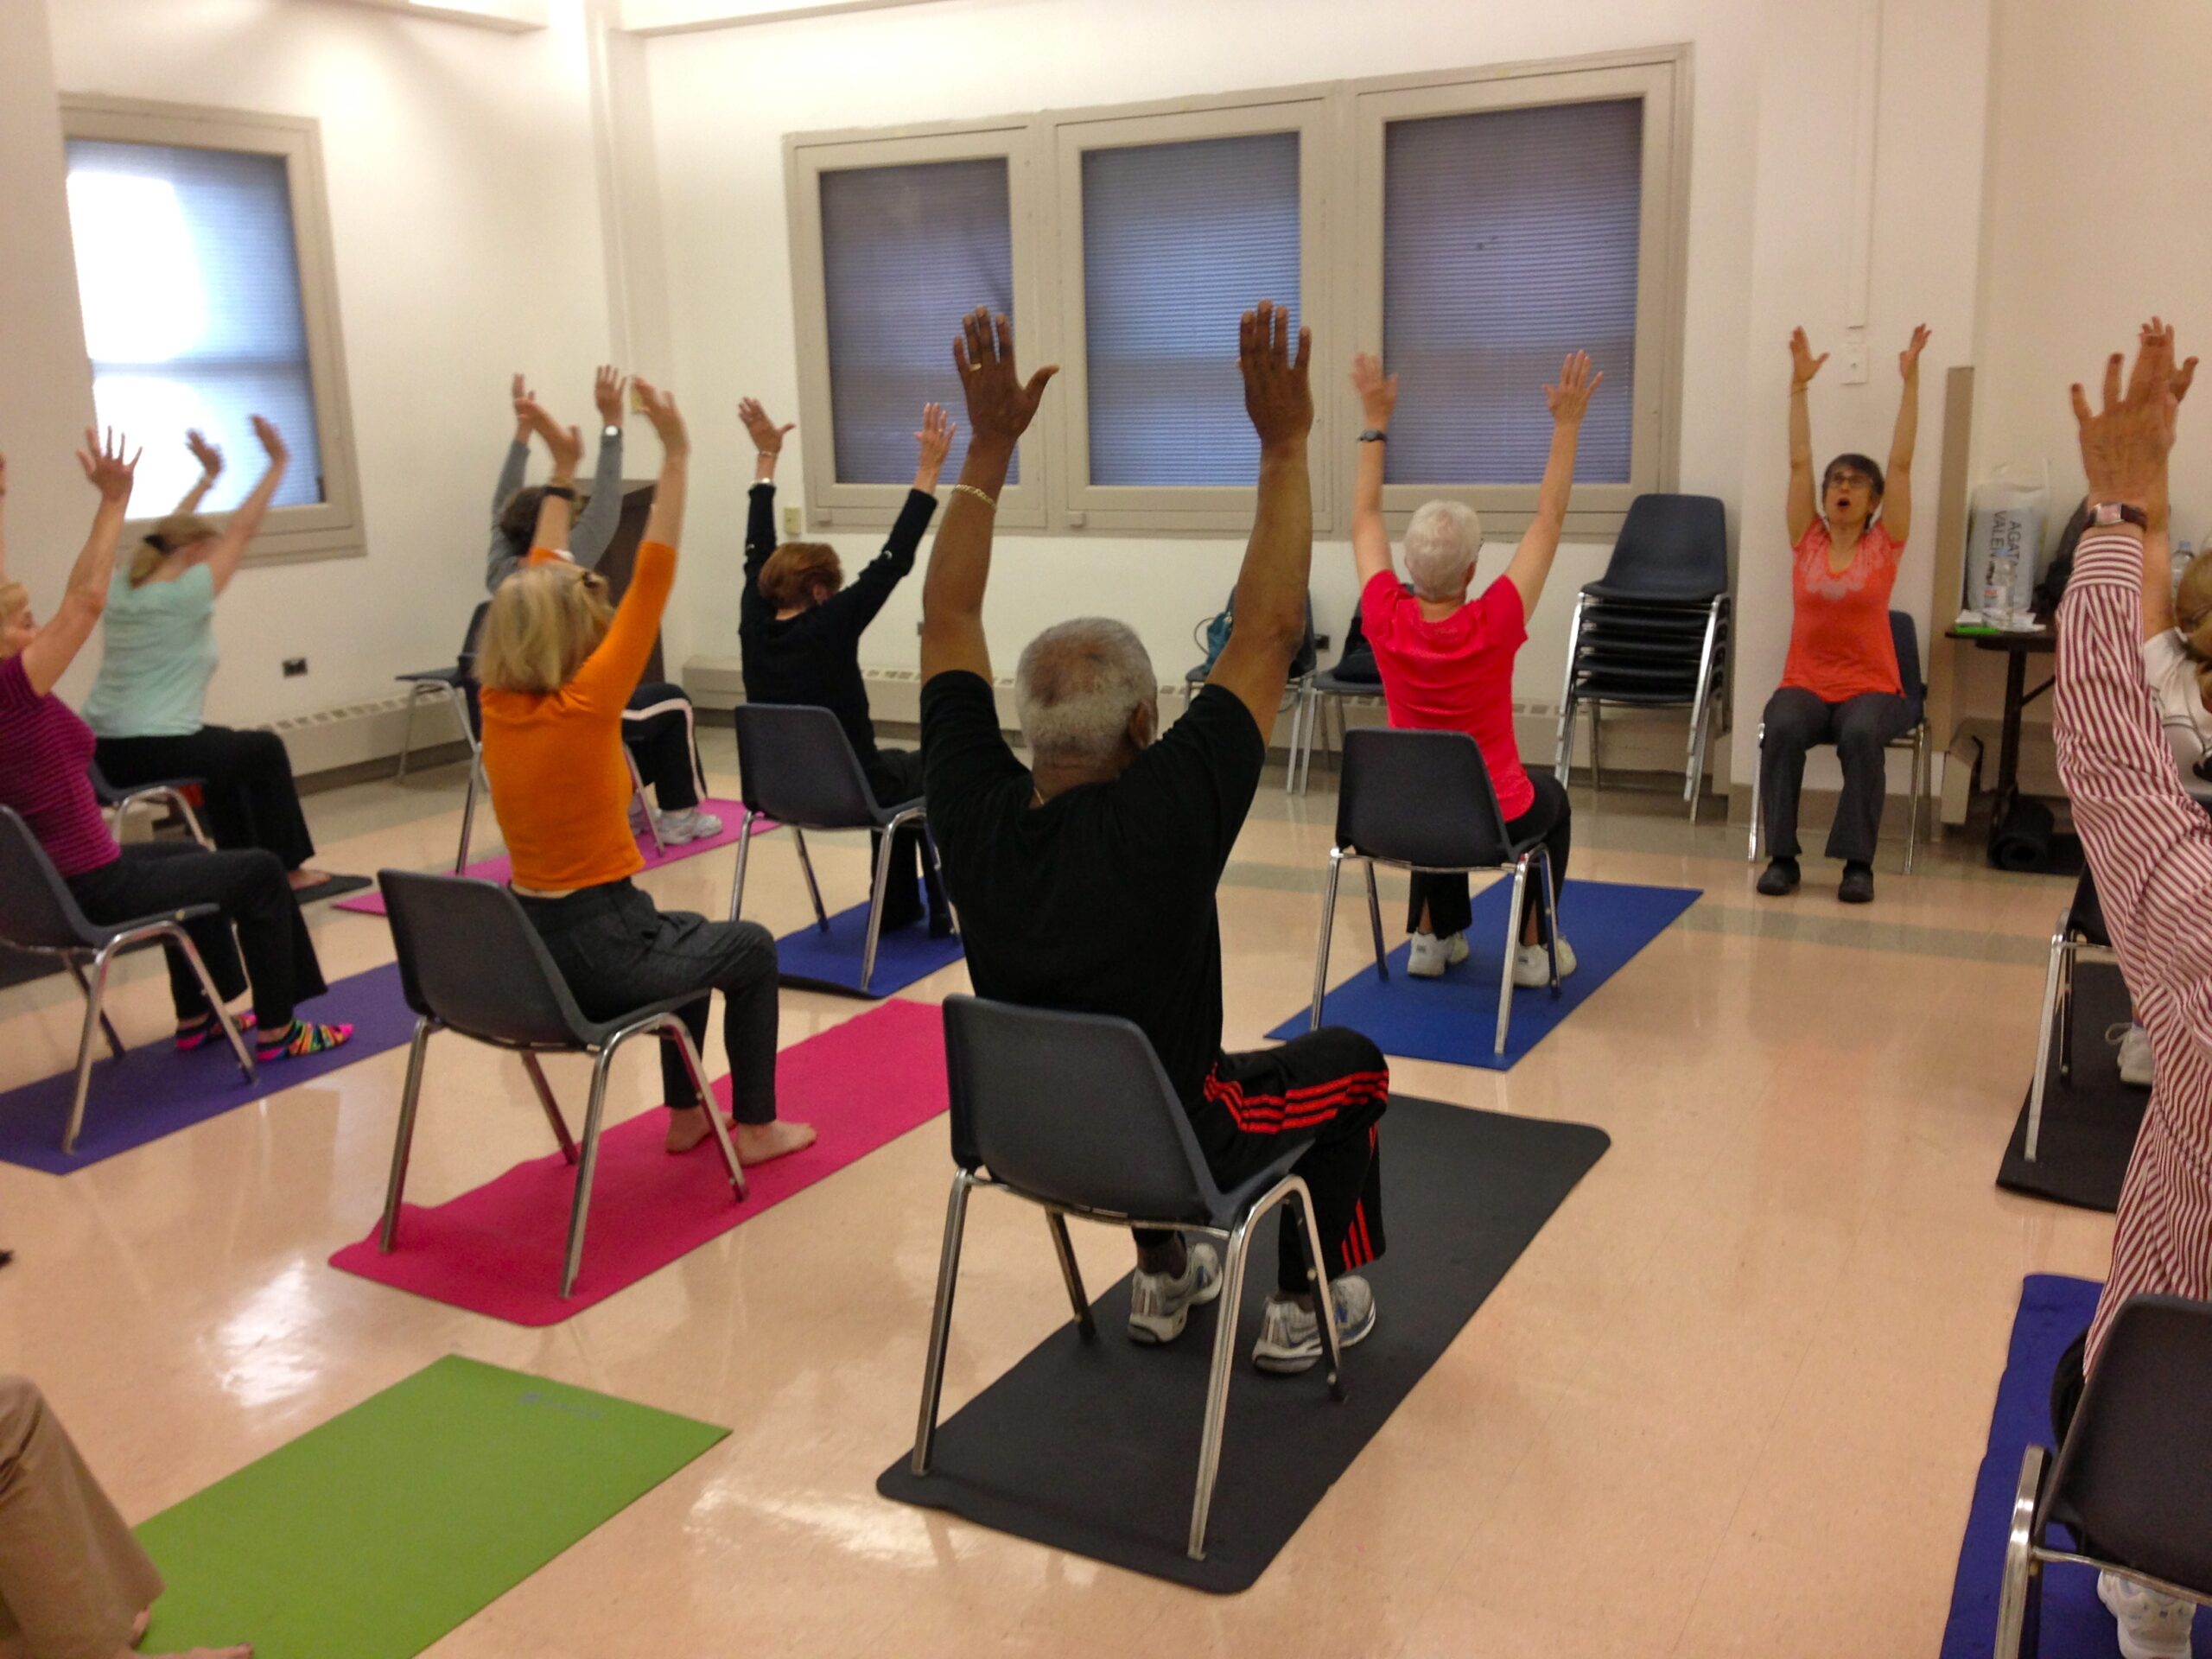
[[783, 118, 1058, 531]]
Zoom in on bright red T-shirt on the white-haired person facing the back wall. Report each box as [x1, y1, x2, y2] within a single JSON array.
[[1360, 570, 1535, 818]]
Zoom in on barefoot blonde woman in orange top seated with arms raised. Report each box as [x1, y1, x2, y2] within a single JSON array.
[[475, 380, 814, 1164]]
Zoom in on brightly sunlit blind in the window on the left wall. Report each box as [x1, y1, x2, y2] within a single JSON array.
[[68, 139, 323, 518]]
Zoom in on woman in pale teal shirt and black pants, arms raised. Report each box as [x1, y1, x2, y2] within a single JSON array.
[[84, 416, 327, 889]]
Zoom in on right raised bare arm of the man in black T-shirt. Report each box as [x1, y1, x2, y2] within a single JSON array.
[[1208, 299, 1314, 739]]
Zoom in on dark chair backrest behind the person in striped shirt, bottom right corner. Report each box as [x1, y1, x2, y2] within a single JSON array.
[[2050, 1296, 2212, 1595]]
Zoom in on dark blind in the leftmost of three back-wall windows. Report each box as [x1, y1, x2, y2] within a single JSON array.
[[821, 157, 1013, 485]]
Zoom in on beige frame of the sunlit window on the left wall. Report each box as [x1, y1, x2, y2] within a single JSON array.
[[60, 93, 370, 564]]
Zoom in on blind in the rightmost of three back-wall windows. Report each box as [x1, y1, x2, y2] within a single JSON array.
[[1382, 98, 1643, 485]]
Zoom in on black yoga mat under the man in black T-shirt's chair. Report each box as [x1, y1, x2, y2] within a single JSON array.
[[876, 1095, 1611, 1595]]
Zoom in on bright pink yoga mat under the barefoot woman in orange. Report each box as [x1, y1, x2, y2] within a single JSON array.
[[329, 1002, 947, 1325]]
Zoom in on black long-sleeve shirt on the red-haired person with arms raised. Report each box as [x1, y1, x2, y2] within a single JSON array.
[[736, 482, 938, 777]]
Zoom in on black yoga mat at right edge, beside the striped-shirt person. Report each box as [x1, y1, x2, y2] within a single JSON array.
[[1998, 963, 2150, 1212]]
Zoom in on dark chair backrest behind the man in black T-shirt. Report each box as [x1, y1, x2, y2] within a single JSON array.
[[944, 995, 1224, 1221]]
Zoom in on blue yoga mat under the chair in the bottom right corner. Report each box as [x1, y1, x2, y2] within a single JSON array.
[[1942, 1274, 2212, 1659]]
